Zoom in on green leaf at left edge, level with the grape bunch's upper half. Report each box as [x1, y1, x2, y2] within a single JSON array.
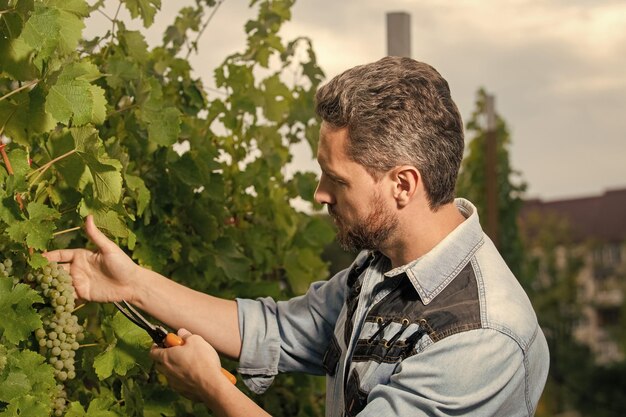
[[0, 277, 43, 344]]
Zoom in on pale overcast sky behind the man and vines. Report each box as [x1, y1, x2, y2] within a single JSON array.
[[86, 0, 626, 200]]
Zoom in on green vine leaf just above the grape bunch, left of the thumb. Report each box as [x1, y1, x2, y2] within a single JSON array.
[[6, 201, 59, 250]]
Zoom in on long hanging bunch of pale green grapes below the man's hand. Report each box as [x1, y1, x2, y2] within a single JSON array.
[[26, 263, 85, 416]]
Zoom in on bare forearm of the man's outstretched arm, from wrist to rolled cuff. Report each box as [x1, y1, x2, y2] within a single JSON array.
[[132, 267, 241, 359]]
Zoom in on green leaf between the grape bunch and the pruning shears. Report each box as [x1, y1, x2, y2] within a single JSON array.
[[93, 312, 152, 380]]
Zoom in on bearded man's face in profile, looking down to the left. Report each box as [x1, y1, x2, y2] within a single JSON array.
[[315, 123, 398, 251]]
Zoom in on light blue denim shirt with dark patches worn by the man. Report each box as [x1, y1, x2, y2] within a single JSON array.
[[237, 199, 549, 417]]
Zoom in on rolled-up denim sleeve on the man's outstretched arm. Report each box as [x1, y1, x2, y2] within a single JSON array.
[[237, 270, 347, 394]]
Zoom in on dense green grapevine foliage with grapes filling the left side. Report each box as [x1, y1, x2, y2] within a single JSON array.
[[0, 0, 333, 417]]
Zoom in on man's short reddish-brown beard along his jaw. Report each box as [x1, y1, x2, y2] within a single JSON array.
[[328, 194, 398, 252]]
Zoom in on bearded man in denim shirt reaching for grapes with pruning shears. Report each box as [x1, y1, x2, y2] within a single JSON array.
[[47, 57, 548, 417]]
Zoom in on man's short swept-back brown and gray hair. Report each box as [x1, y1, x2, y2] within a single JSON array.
[[315, 57, 464, 210]]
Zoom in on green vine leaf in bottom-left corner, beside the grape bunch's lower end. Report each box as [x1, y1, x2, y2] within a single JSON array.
[[0, 349, 56, 404]]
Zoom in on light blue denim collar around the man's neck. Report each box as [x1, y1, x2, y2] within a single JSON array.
[[385, 198, 484, 304]]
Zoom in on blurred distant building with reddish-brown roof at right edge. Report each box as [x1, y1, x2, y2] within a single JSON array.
[[520, 189, 626, 364]]
